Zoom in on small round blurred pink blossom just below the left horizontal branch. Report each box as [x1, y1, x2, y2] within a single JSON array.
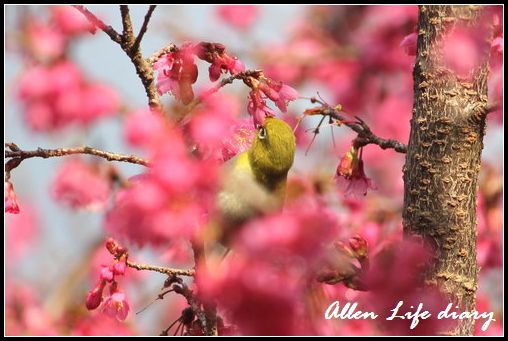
[[52, 158, 110, 209]]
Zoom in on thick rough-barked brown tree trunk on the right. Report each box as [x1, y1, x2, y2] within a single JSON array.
[[403, 6, 492, 335]]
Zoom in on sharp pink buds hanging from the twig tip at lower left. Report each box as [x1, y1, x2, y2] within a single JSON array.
[[86, 238, 130, 321]]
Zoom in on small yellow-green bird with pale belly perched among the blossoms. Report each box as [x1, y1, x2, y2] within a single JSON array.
[[212, 117, 296, 243]]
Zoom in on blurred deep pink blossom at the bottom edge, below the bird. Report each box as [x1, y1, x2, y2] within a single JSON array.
[[196, 255, 308, 335]]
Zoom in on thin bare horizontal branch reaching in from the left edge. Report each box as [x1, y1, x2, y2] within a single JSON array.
[[5, 143, 149, 172]]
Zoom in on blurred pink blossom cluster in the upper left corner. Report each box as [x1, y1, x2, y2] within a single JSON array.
[[13, 6, 120, 132]]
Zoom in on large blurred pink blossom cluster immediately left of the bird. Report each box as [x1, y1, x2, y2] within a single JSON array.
[[105, 110, 220, 246]]
